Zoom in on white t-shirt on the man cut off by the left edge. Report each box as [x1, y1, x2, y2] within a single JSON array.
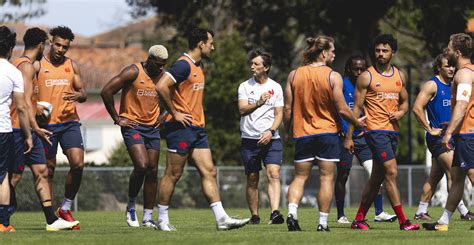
[[0, 58, 23, 133]]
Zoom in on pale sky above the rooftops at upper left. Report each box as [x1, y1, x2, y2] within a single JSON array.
[[10, 0, 152, 37]]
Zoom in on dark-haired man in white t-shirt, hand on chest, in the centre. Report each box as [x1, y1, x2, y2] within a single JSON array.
[[238, 49, 284, 224]]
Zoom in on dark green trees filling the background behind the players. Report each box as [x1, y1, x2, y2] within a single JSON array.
[[127, 0, 474, 165]]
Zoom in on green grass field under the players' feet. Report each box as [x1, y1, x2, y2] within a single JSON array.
[[0, 208, 474, 245]]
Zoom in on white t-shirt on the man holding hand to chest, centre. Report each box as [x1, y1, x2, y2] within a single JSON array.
[[238, 77, 283, 139]]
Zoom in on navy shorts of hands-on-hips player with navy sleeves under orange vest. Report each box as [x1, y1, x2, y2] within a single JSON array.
[[161, 122, 209, 154]]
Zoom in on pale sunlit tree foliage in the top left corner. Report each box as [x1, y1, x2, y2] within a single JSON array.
[[0, 0, 46, 22]]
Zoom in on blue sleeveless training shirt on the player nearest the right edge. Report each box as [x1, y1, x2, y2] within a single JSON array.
[[426, 76, 451, 137]]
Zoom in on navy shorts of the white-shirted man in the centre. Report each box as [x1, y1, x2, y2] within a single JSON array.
[[240, 138, 283, 174]]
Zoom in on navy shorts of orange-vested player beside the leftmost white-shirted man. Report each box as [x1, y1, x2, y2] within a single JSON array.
[[10, 130, 46, 174]]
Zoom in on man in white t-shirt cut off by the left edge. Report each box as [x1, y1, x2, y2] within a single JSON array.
[[0, 26, 33, 233]]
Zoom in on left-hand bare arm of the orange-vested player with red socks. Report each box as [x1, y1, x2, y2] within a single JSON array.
[[344, 71, 370, 153]]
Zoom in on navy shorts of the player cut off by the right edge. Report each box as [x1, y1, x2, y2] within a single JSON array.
[[453, 135, 474, 170]]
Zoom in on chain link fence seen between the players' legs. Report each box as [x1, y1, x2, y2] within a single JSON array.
[[12, 165, 474, 211]]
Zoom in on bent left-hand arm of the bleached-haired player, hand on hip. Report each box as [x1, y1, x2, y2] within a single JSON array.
[[100, 65, 139, 128]]
